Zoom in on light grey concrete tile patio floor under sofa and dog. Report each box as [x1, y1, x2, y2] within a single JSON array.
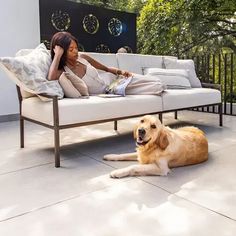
[[0, 111, 236, 236]]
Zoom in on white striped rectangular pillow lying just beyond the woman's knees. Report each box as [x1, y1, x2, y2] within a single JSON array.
[[143, 68, 191, 89]]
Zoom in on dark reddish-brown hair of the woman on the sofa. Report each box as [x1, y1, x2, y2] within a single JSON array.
[[50, 32, 78, 70]]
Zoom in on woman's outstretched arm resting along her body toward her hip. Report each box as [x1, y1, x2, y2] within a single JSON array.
[[80, 53, 132, 77]]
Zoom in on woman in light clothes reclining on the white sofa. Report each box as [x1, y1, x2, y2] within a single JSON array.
[[48, 32, 164, 94]]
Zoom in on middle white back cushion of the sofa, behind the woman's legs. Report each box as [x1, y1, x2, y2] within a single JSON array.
[[116, 53, 177, 74]]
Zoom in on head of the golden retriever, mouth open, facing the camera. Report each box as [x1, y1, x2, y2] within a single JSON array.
[[134, 115, 169, 149]]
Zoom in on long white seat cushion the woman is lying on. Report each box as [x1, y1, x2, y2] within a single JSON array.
[[22, 95, 162, 125]]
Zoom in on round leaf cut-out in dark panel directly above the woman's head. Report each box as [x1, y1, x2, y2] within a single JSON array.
[[51, 10, 70, 31]]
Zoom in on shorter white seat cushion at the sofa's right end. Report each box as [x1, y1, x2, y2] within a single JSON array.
[[162, 88, 221, 111]]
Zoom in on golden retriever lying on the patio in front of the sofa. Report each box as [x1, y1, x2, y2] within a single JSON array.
[[103, 115, 208, 178]]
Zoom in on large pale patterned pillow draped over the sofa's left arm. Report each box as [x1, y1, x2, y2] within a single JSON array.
[[0, 44, 64, 98]]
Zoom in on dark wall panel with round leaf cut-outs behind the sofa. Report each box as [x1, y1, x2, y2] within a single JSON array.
[[39, 0, 136, 53]]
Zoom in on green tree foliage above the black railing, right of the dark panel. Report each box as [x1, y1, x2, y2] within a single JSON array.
[[138, 0, 236, 56]]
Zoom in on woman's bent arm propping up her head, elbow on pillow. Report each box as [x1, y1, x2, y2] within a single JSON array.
[[48, 45, 64, 80]]
